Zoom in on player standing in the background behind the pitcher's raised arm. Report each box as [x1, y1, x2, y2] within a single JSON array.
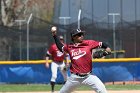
[[45, 36, 68, 93]]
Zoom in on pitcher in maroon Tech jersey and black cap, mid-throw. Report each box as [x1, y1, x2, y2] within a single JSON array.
[[51, 27, 111, 93]]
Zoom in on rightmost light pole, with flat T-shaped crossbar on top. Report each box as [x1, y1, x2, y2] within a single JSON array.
[[108, 13, 120, 58]]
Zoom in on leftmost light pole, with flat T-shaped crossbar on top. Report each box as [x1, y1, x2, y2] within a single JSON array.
[[15, 20, 26, 60]]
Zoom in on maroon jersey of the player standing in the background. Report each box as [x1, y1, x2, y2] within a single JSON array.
[[47, 44, 65, 62]]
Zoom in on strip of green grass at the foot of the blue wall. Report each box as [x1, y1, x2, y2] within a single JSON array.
[[0, 84, 140, 92]]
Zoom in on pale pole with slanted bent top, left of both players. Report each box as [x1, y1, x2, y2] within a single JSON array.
[[27, 13, 32, 61]]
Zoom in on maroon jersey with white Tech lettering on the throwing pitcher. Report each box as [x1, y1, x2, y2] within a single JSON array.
[[63, 40, 102, 73]]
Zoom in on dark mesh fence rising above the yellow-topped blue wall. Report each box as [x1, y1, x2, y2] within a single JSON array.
[[0, 17, 140, 60]]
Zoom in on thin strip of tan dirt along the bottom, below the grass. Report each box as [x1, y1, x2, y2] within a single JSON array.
[[0, 90, 140, 93]]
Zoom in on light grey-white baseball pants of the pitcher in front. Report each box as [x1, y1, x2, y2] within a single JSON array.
[[59, 74, 107, 93]]
